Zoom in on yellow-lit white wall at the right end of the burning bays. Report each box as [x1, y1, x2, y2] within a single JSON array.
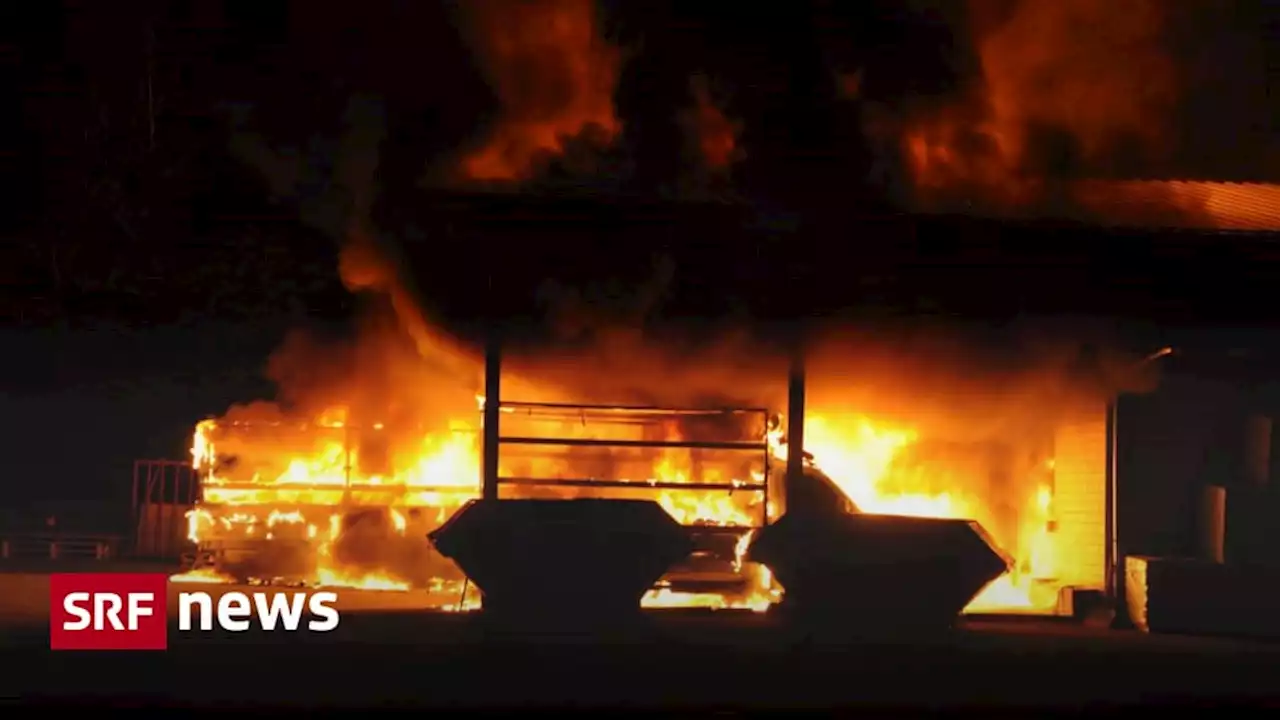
[[1053, 404, 1107, 589]]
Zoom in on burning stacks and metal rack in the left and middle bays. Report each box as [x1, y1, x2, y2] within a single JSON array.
[[183, 401, 772, 605]]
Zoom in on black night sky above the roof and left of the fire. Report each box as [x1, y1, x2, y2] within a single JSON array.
[[0, 0, 1280, 529]]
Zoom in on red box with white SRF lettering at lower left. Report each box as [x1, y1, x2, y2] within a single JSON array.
[[49, 573, 169, 650]]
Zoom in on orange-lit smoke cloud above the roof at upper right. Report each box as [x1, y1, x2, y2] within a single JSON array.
[[902, 0, 1175, 196]]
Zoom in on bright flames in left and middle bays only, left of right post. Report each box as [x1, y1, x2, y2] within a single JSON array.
[[183, 396, 777, 602]]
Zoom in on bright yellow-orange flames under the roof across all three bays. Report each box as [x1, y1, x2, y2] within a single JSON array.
[[183, 397, 1080, 611]]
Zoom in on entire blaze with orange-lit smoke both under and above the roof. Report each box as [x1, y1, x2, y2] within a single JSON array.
[[183, 0, 1167, 612]]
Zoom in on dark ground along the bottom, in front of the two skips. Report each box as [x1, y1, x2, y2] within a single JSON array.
[[0, 566, 1280, 707]]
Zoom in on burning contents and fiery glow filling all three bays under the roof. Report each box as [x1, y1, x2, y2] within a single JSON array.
[[179, 322, 1105, 612]]
